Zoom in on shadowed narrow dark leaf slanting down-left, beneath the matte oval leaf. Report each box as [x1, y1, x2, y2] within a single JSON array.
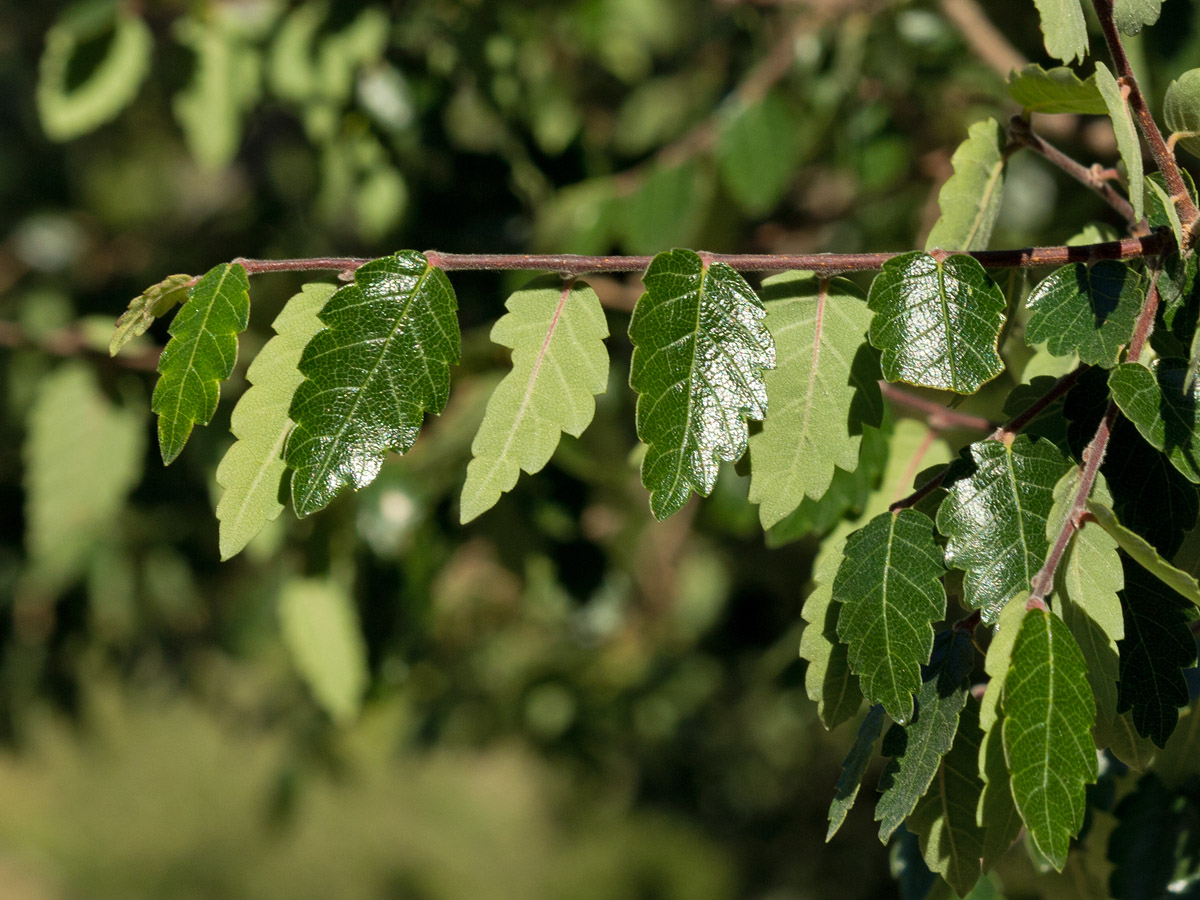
[[875, 630, 974, 841]]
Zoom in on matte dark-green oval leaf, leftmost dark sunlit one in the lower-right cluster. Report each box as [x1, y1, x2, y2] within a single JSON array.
[[833, 509, 946, 724]]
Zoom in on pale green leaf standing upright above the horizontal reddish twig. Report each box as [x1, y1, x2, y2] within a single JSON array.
[[925, 119, 1007, 251]]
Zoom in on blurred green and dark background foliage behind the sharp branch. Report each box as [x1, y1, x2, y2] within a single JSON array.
[[0, 0, 1200, 900]]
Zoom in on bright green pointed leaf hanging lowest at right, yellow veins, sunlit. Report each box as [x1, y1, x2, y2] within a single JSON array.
[[1002, 610, 1098, 871]]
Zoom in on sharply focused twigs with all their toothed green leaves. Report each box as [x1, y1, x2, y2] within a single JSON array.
[[100, 0, 1200, 894]]
